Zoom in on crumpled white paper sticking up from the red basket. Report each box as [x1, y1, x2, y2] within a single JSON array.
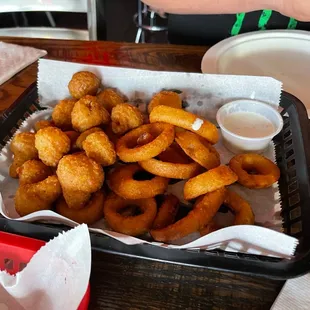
[[0, 224, 91, 310]]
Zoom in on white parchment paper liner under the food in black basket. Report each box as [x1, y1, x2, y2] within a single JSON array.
[[0, 59, 298, 257]]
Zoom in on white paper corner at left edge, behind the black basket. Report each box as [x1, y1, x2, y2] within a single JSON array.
[[0, 42, 47, 85]]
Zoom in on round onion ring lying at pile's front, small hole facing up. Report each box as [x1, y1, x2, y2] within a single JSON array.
[[103, 193, 157, 236]]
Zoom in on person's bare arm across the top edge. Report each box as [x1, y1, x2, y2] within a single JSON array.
[[143, 0, 310, 21]]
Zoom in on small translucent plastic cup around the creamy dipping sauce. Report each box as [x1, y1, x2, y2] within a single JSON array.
[[216, 99, 283, 154]]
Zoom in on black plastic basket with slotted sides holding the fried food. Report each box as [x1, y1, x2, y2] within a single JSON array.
[[0, 85, 310, 279]]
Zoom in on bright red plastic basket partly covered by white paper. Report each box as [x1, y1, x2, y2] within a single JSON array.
[[0, 232, 90, 310]]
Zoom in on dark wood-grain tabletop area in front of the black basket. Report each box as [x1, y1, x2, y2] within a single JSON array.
[[90, 253, 282, 310]]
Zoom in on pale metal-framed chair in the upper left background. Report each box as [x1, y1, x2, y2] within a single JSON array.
[[0, 0, 97, 40]]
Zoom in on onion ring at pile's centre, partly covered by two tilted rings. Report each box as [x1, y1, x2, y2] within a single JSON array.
[[139, 146, 201, 179]]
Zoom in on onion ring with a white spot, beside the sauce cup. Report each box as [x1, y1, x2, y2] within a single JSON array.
[[150, 105, 219, 144]]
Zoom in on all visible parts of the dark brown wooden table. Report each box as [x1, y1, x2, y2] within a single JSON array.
[[0, 37, 283, 310]]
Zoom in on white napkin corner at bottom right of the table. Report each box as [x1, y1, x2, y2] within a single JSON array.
[[271, 273, 310, 310]]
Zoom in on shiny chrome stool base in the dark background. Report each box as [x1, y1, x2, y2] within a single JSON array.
[[134, 0, 167, 43]]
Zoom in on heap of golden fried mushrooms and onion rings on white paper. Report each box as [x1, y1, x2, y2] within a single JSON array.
[[10, 71, 280, 243]]
